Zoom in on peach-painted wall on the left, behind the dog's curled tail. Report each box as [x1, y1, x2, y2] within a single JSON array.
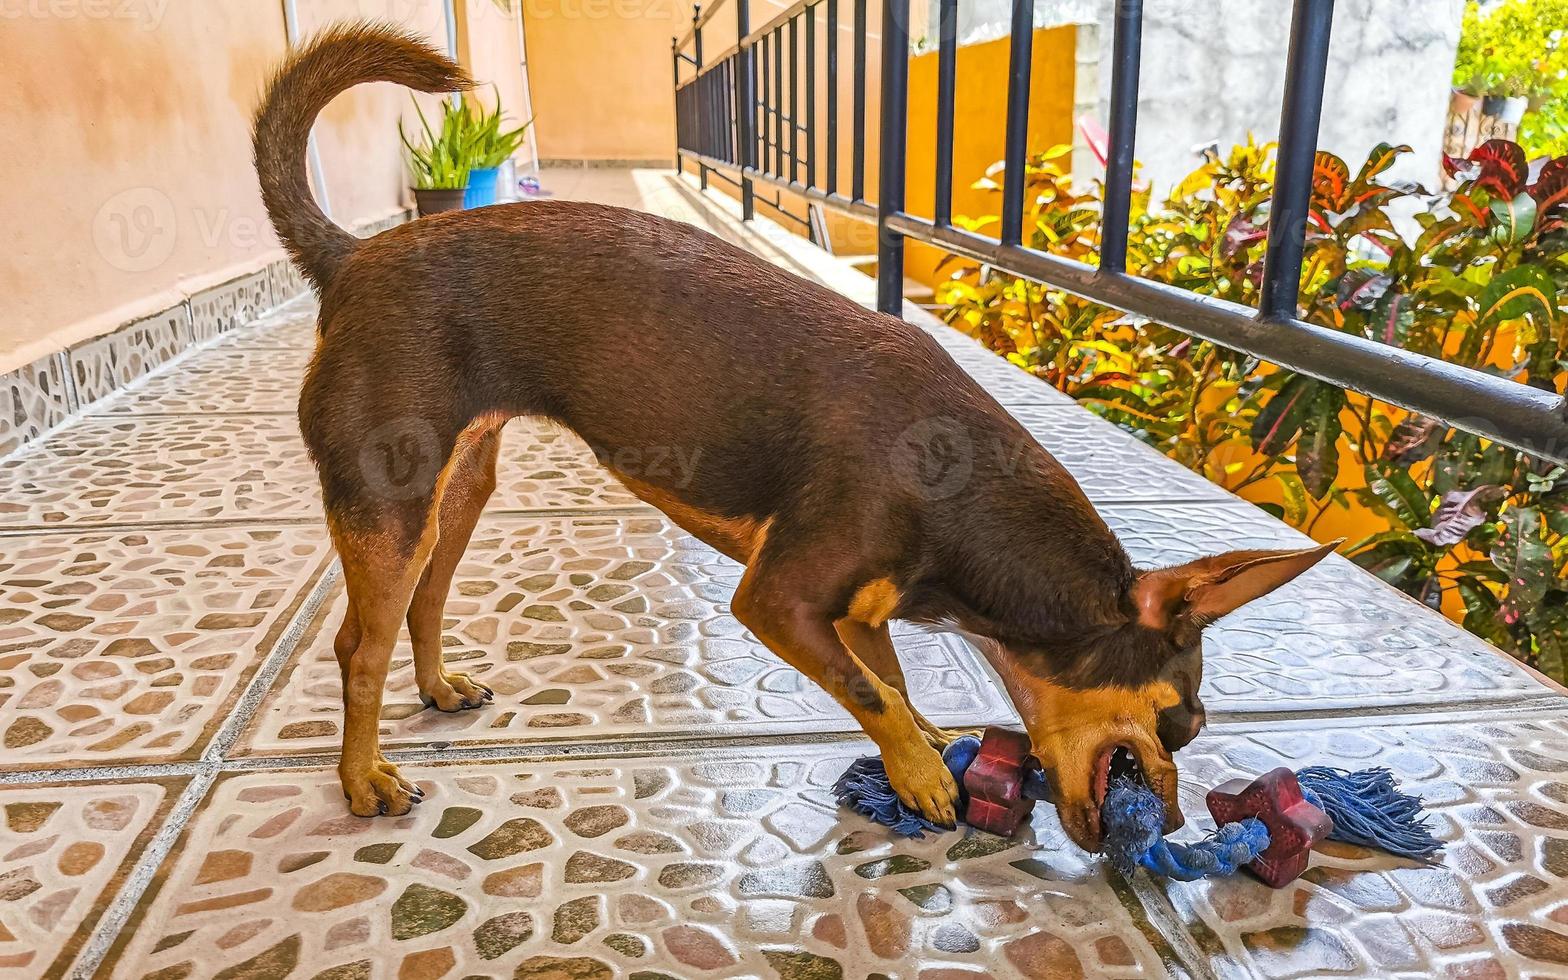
[[0, 0, 521, 373]]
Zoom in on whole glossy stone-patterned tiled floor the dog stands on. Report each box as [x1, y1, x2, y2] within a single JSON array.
[[0, 171, 1568, 980]]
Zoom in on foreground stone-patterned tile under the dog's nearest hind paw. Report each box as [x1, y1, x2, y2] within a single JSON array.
[[110, 743, 1179, 980]]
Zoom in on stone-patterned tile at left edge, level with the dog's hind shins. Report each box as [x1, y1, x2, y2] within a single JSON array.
[[0, 527, 329, 770]]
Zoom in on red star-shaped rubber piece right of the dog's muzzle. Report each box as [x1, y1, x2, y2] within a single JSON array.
[[1207, 767, 1334, 887]]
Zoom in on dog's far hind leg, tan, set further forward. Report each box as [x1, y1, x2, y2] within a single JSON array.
[[408, 428, 500, 712]]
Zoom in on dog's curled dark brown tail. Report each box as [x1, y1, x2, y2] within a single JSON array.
[[252, 24, 474, 292]]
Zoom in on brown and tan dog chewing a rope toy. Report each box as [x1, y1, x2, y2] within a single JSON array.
[[256, 25, 1330, 850]]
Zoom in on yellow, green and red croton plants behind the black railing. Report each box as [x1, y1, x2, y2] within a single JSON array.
[[938, 140, 1568, 681]]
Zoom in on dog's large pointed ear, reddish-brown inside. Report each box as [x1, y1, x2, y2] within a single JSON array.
[[1132, 539, 1342, 648]]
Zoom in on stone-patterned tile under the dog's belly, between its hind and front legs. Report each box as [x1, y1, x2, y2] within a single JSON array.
[[246, 517, 1013, 753]]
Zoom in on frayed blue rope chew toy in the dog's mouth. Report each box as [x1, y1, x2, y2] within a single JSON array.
[[833, 729, 1443, 887]]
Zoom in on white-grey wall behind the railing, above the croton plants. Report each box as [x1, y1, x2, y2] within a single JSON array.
[[930, 0, 1463, 193]]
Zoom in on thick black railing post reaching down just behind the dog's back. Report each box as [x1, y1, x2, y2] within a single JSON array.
[[877, 0, 909, 317]]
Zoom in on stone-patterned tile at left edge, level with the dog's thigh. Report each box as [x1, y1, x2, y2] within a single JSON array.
[[0, 416, 321, 527]]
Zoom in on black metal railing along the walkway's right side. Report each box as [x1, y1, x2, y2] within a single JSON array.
[[674, 0, 1568, 463]]
